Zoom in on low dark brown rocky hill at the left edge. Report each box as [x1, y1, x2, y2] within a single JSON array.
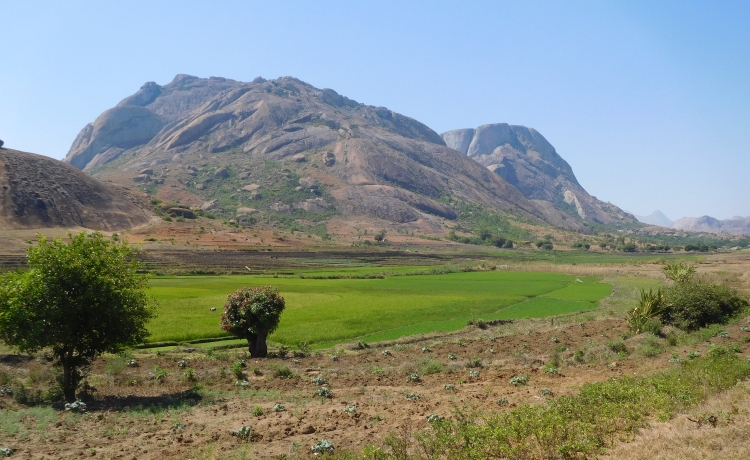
[[0, 149, 151, 231]]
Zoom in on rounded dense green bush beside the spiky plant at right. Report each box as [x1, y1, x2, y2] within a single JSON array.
[[661, 281, 748, 331]]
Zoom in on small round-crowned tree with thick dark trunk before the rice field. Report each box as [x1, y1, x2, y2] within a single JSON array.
[[221, 286, 286, 358]]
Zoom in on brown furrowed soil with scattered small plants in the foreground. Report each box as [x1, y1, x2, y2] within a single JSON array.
[[5, 313, 750, 459]]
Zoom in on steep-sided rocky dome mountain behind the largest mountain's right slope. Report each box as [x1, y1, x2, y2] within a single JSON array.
[[442, 123, 636, 224]]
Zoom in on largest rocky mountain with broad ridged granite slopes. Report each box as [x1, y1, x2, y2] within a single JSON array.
[[64, 75, 596, 235]]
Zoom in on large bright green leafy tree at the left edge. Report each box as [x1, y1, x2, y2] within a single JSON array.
[[0, 232, 154, 402]]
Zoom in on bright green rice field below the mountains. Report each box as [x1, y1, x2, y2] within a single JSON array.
[[148, 267, 612, 345]]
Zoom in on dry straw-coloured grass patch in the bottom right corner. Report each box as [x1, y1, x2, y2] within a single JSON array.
[[600, 383, 750, 460]]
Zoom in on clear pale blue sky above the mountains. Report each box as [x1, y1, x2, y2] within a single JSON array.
[[0, 0, 750, 219]]
